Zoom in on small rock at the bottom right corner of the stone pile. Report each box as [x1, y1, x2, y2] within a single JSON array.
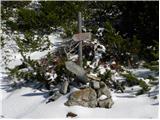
[[98, 98, 114, 108]]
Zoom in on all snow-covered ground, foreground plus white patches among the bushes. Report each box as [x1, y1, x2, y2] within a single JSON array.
[[0, 35, 159, 118]]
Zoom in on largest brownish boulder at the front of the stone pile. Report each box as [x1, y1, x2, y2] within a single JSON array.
[[65, 88, 97, 107]]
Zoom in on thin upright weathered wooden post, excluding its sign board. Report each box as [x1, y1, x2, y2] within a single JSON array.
[[78, 12, 83, 67]]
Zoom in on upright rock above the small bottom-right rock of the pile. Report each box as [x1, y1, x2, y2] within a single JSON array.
[[97, 82, 111, 98]]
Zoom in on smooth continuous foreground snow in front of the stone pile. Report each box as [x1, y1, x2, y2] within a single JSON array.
[[2, 83, 158, 118]]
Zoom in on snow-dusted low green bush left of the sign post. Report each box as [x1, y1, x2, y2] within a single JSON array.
[[8, 53, 56, 89]]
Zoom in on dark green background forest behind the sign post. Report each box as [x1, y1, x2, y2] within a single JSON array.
[[1, 1, 159, 62]]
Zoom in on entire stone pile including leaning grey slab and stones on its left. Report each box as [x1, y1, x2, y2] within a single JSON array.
[[46, 61, 114, 108]]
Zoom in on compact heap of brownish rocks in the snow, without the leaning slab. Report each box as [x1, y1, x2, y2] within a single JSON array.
[[65, 81, 114, 108]]
